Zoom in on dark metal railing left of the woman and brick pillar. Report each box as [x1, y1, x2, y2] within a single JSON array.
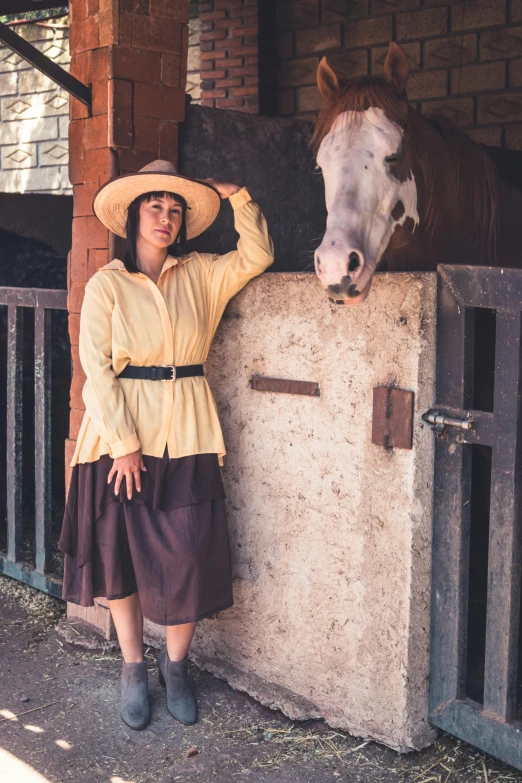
[[0, 286, 67, 597]]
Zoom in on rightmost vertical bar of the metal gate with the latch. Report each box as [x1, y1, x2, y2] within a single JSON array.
[[484, 309, 521, 721]]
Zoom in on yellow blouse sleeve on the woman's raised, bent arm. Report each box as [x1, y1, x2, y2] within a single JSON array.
[[205, 188, 274, 304]]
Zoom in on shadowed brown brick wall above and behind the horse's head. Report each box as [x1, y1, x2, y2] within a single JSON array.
[[275, 0, 522, 149]]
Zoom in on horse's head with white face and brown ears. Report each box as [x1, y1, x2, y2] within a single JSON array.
[[308, 43, 419, 304]]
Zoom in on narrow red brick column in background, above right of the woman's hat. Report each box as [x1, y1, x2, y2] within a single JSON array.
[[199, 0, 262, 114]]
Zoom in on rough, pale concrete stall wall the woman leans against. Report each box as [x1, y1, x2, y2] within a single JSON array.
[[144, 273, 436, 751]]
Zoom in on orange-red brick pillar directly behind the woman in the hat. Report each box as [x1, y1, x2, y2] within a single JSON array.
[[66, 0, 189, 635]]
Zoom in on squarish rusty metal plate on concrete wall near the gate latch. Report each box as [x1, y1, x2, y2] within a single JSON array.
[[372, 386, 413, 449]]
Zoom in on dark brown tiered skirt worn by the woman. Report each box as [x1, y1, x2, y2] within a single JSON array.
[[59, 451, 233, 625]]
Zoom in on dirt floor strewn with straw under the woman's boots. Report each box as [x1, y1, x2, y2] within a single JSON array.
[[0, 576, 522, 783]]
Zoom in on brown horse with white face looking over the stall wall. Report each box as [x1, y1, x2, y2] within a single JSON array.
[[312, 43, 522, 305]]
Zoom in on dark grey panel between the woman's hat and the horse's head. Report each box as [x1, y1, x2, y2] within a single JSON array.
[[179, 104, 326, 272]]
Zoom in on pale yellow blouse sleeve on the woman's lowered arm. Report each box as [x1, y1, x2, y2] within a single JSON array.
[[80, 272, 140, 459]]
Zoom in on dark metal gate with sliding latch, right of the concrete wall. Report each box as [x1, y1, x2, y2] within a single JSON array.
[[424, 266, 522, 769]]
